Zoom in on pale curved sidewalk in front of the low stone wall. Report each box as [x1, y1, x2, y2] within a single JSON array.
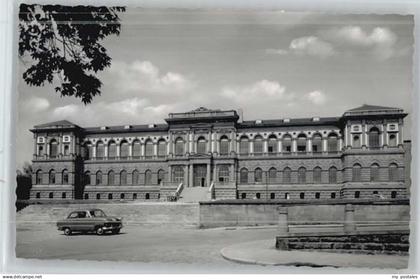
[[220, 239, 408, 269]]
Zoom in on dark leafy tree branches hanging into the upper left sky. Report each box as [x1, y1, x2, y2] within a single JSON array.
[[19, 4, 125, 104]]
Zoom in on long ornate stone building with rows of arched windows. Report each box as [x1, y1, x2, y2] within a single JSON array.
[[31, 105, 409, 200]]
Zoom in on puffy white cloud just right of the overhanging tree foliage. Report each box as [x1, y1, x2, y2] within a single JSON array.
[[109, 60, 194, 94]]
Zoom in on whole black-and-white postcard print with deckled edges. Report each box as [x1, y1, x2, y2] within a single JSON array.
[[14, 2, 415, 273]]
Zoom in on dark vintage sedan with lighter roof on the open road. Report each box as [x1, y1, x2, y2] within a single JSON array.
[[57, 209, 122, 235]]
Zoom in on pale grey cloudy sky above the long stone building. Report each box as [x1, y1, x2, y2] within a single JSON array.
[[16, 8, 414, 168]]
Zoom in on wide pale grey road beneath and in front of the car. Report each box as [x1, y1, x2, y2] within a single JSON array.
[[16, 223, 276, 266]]
